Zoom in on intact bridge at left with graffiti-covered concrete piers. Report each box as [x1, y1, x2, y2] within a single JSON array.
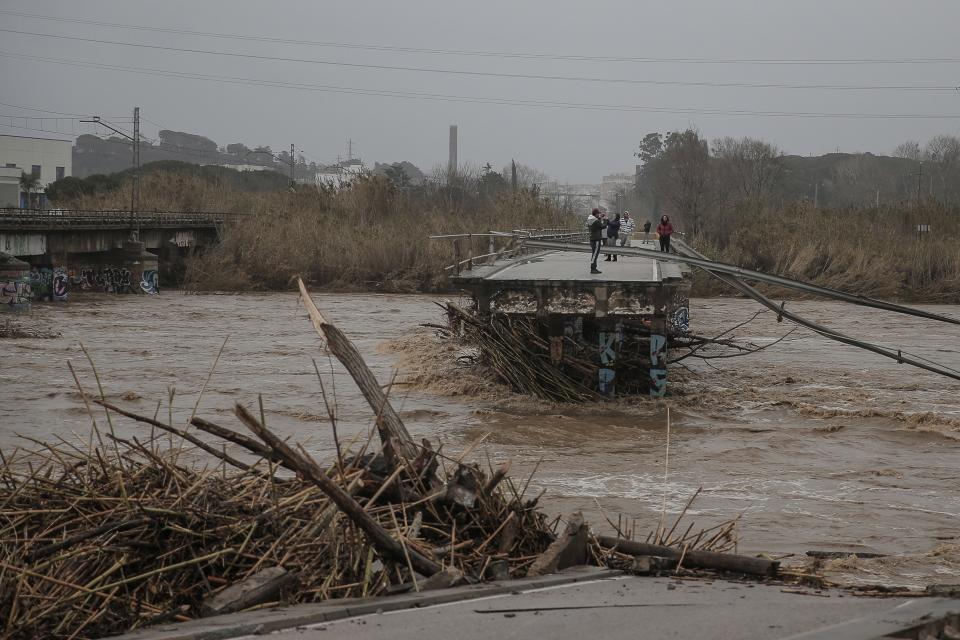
[[0, 209, 243, 310]]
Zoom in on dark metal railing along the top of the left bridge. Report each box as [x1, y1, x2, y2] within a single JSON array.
[[0, 207, 248, 229]]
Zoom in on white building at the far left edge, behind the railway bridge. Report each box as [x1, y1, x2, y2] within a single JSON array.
[[0, 135, 73, 207]]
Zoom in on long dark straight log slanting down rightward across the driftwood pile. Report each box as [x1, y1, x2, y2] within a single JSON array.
[[234, 404, 442, 576]]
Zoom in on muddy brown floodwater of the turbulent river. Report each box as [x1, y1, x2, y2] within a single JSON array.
[[0, 292, 960, 586]]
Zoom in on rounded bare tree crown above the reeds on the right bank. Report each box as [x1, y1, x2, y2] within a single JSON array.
[[713, 137, 783, 202]]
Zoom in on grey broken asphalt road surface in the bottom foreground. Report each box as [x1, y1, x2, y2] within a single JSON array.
[[109, 567, 960, 640]]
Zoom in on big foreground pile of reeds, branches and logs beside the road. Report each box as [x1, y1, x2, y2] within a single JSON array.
[[0, 284, 776, 640]]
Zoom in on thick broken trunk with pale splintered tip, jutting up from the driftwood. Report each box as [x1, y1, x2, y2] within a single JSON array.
[[297, 278, 417, 460]]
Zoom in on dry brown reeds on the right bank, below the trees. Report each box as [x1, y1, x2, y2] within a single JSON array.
[[693, 203, 960, 303]]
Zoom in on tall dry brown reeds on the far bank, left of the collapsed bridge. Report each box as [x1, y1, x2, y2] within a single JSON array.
[[58, 166, 578, 292]]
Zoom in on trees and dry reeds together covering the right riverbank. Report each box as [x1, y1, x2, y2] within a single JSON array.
[[627, 129, 960, 302]]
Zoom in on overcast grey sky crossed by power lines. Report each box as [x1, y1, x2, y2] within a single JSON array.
[[0, 0, 960, 182]]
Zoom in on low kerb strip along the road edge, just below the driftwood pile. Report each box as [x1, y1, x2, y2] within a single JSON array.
[[110, 566, 623, 640]]
